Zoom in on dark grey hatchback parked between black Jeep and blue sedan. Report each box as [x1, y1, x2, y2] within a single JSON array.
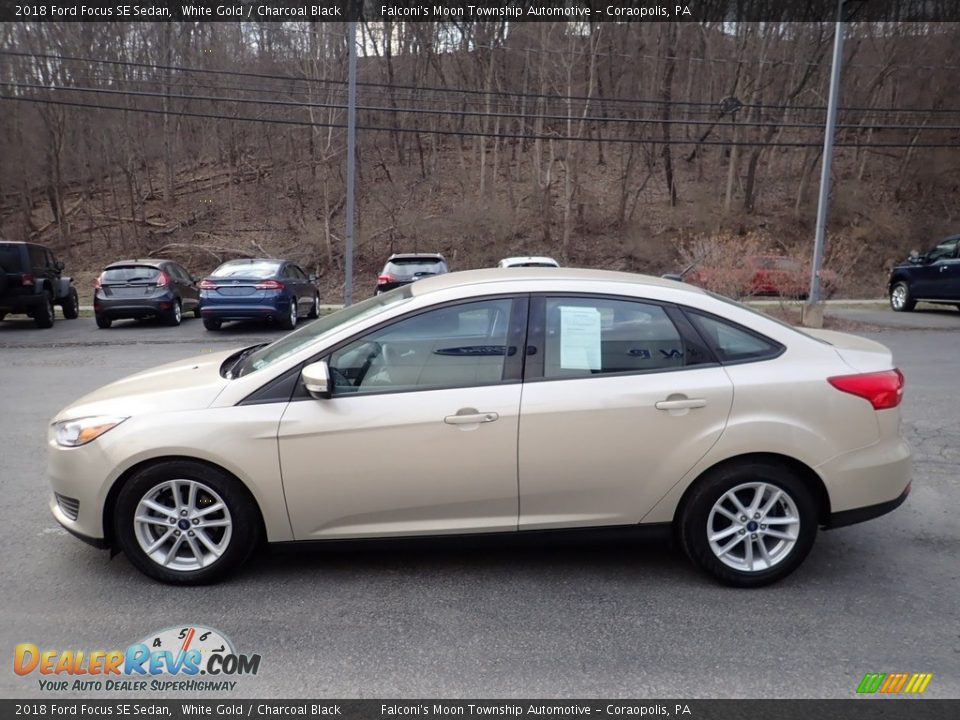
[[93, 260, 200, 329]]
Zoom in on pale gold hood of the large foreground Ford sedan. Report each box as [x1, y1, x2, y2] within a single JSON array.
[[52, 348, 237, 422]]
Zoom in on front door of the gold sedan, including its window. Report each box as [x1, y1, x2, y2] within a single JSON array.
[[279, 298, 526, 540]]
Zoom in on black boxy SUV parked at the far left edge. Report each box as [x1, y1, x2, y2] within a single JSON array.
[[0, 240, 80, 328]]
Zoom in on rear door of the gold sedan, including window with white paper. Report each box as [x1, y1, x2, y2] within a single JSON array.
[[518, 295, 733, 530]]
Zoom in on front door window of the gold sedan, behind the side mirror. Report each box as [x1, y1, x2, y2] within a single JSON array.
[[329, 299, 517, 395]]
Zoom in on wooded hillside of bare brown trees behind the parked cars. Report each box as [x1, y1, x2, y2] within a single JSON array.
[[0, 22, 960, 302]]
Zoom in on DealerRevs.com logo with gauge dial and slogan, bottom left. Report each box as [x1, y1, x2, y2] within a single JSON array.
[[13, 625, 260, 692]]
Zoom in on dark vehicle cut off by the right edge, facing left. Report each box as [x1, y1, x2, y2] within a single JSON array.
[[887, 235, 960, 312]]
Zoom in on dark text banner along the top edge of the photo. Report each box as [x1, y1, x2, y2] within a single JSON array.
[[0, 0, 960, 23]]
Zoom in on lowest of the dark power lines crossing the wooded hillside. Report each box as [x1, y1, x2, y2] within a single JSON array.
[[0, 95, 960, 149]]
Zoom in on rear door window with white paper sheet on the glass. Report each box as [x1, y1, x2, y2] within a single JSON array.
[[543, 297, 707, 379]]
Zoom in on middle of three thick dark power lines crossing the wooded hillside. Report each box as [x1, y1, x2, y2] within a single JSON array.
[[0, 82, 960, 131]]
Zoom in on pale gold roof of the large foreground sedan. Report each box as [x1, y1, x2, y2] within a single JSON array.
[[411, 267, 704, 295]]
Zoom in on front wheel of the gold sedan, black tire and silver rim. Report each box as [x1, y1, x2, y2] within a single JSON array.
[[113, 460, 261, 585]]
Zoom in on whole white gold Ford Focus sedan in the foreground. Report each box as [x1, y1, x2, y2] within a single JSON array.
[[48, 268, 910, 587]]
